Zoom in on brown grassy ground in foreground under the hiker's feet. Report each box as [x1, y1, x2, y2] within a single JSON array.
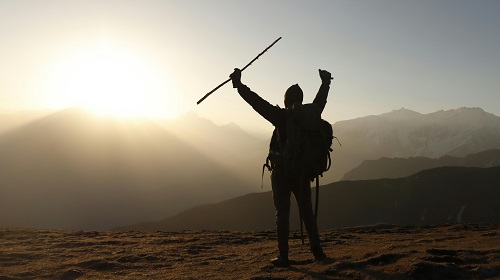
[[0, 224, 500, 280]]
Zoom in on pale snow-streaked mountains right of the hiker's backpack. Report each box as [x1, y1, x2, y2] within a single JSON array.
[[325, 108, 500, 182]]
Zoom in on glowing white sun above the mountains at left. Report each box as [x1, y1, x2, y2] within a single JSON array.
[[44, 45, 177, 118]]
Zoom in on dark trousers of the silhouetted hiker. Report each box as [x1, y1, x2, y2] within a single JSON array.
[[271, 168, 320, 254]]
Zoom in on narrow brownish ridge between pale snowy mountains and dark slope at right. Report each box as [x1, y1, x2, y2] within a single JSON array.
[[343, 150, 500, 181]]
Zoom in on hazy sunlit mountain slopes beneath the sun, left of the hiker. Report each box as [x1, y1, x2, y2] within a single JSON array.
[[0, 109, 265, 229]]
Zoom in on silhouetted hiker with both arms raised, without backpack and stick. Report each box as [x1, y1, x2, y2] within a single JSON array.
[[230, 68, 332, 266]]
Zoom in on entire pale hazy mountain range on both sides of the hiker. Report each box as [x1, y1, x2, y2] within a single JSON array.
[[0, 108, 500, 230]]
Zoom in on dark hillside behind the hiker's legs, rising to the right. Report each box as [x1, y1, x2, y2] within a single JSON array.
[[117, 166, 500, 231]]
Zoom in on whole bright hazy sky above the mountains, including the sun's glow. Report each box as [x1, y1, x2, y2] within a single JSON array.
[[0, 0, 500, 130]]
